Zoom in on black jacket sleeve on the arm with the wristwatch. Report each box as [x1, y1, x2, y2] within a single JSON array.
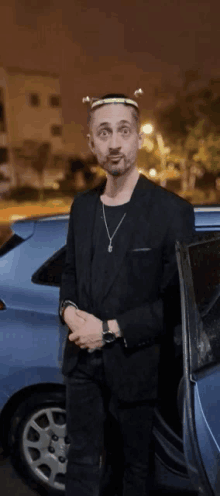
[[115, 204, 194, 348]]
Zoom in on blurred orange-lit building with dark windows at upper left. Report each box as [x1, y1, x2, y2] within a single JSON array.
[[0, 67, 65, 192]]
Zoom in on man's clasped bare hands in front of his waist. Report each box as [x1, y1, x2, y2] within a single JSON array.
[[67, 309, 103, 350]]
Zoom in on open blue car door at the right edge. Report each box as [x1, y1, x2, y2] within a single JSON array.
[[176, 234, 220, 496]]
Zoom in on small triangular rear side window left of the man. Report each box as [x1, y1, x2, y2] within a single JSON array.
[[31, 246, 66, 287]]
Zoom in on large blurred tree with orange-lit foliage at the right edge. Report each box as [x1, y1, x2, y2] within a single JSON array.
[[155, 70, 220, 191]]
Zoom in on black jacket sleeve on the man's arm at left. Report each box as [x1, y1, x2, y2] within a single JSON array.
[[59, 200, 77, 324]]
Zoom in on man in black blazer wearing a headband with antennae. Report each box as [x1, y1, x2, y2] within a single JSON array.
[[60, 90, 194, 496]]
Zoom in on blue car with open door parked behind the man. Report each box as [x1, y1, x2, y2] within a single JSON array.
[[0, 206, 220, 496]]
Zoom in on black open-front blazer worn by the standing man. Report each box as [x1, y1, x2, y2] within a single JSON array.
[[60, 175, 194, 402]]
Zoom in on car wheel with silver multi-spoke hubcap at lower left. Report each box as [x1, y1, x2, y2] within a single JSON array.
[[9, 392, 69, 496]]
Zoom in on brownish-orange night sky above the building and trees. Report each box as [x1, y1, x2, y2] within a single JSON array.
[[0, 0, 220, 150]]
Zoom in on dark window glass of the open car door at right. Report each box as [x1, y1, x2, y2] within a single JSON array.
[[189, 235, 220, 370]]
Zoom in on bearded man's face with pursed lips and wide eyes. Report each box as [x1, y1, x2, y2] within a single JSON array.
[[89, 103, 142, 176]]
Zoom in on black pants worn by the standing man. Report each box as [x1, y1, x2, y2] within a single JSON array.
[[66, 351, 154, 496]]
